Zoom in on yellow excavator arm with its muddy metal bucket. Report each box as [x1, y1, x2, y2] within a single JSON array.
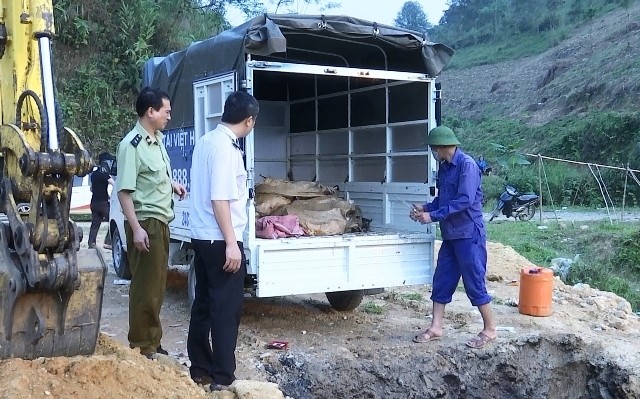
[[0, 0, 106, 359]]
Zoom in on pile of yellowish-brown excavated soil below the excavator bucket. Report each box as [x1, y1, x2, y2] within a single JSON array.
[[0, 334, 206, 398]]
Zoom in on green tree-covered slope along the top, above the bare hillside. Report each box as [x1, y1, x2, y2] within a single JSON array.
[[429, 0, 631, 68]]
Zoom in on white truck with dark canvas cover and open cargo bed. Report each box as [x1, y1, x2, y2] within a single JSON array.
[[110, 15, 453, 310]]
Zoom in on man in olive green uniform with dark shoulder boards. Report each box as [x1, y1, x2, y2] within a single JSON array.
[[116, 87, 186, 358]]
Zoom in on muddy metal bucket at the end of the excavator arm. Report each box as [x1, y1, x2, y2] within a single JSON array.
[[0, 231, 106, 359]]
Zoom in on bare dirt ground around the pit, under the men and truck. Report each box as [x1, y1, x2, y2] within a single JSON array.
[[0, 225, 640, 399]]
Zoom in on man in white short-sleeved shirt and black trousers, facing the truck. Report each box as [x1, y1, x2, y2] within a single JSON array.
[[187, 91, 259, 390]]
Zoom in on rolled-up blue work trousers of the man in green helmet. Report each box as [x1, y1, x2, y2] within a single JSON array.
[[431, 227, 491, 306]]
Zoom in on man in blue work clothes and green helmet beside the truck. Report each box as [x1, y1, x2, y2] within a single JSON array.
[[409, 126, 497, 349]]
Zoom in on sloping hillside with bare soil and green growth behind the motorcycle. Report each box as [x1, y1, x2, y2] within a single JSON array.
[[440, 1, 640, 206]]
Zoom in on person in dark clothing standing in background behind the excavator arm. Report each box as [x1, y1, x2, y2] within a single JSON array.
[[87, 152, 113, 249]]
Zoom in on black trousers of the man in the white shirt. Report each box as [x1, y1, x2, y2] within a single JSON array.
[[187, 239, 246, 385]]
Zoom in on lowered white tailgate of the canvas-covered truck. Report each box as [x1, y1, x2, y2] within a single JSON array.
[[255, 231, 434, 297]]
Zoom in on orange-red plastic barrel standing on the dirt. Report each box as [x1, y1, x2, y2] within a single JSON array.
[[518, 267, 553, 316]]
